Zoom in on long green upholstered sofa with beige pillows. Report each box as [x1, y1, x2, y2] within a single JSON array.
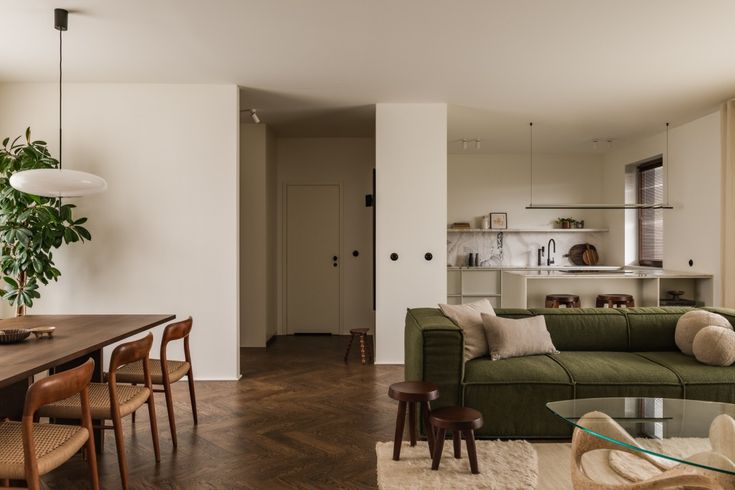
[[405, 307, 735, 438]]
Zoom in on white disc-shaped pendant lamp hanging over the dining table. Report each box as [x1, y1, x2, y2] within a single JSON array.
[[10, 9, 107, 198]]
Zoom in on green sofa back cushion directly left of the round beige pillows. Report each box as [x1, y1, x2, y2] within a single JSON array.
[[620, 306, 692, 352]]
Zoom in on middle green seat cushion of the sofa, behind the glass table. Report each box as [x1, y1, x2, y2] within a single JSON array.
[[550, 352, 682, 398]]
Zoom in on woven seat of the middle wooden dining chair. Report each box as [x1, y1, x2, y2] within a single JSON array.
[[38, 383, 150, 419]]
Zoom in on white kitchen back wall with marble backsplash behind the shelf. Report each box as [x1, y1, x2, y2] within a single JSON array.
[[447, 154, 608, 267]]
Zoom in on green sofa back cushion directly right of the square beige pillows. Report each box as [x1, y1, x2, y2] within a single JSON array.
[[531, 308, 628, 352]]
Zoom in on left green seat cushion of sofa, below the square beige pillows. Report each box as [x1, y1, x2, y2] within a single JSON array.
[[464, 355, 572, 385]]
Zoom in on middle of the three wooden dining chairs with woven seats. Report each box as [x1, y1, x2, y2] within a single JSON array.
[[39, 333, 161, 489]]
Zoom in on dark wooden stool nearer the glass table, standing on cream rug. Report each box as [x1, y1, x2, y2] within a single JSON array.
[[429, 407, 483, 475]]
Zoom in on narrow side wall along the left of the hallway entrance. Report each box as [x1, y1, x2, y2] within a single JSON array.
[[240, 124, 276, 347]]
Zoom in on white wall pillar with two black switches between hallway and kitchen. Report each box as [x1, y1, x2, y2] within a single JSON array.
[[375, 103, 447, 364]]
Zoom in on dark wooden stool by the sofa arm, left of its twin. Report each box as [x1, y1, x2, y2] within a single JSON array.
[[388, 381, 439, 461]]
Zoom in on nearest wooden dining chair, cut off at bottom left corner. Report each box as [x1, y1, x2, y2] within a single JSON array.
[[0, 359, 100, 490]]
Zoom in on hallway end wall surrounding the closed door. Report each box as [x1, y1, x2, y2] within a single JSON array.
[[276, 138, 375, 334]]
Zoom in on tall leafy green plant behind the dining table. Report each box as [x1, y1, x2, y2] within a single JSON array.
[[0, 128, 92, 315]]
